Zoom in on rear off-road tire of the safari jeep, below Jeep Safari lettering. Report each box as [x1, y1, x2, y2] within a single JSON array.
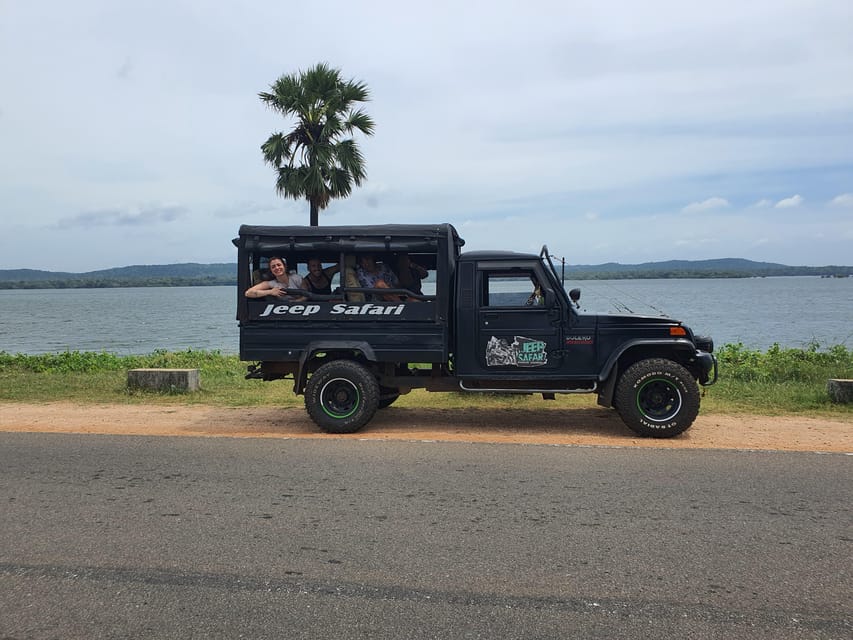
[[305, 360, 379, 433]]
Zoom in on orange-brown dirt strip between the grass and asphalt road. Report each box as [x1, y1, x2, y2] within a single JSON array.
[[0, 402, 853, 453]]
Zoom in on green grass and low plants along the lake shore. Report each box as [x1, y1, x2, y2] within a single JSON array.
[[0, 343, 853, 416]]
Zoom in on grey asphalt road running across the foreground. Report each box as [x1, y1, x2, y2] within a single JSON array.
[[0, 433, 853, 640]]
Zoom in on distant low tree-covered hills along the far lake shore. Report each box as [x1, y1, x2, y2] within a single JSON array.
[[0, 258, 853, 289]]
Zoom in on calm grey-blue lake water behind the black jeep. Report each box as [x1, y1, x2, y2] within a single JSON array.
[[0, 276, 853, 355]]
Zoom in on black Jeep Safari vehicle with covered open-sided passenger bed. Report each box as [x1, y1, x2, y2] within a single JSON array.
[[234, 224, 717, 438]]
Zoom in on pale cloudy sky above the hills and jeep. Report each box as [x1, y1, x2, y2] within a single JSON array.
[[0, 0, 853, 272]]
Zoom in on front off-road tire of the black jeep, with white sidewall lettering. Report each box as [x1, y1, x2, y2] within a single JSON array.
[[615, 358, 699, 438]]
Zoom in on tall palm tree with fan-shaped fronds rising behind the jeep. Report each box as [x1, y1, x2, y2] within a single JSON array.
[[258, 63, 374, 227]]
